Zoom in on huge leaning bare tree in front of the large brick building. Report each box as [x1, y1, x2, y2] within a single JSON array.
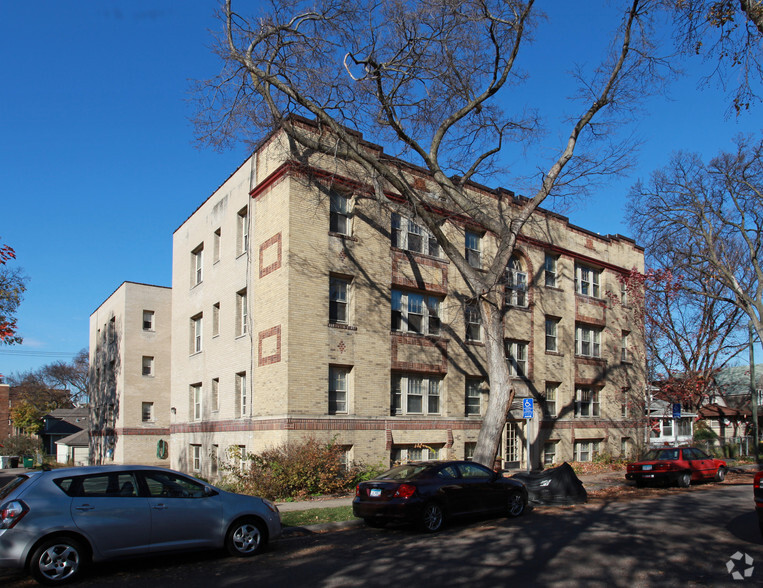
[[197, 0, 668, 465]]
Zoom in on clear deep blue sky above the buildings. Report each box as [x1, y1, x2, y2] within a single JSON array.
[[0, 0, 760, 374]]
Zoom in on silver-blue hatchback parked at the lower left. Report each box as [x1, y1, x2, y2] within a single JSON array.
[[0, 466, 281, 585]]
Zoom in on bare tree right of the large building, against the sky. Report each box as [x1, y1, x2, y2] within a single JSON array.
[[629, 137, 763, 370]]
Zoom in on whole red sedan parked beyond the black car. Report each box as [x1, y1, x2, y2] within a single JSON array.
[[625, 447, 727, 488]]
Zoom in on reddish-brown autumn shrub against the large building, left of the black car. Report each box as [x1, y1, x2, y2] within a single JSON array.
[[222, 438, 377, 500]]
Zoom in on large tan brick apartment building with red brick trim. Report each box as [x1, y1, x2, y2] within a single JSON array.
[[170, 129, 644, 477]]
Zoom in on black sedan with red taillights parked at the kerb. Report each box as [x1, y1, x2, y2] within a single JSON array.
[[352, 461, 527, 533]]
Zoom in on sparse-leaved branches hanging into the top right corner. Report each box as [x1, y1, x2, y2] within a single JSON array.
[[665, 0, 763, 114]]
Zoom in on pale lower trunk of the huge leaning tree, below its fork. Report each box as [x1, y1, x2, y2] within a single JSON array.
[[474, 288, 514, 467]]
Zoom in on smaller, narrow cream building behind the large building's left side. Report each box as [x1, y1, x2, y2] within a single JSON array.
[[89, 282, 172, 465]]
